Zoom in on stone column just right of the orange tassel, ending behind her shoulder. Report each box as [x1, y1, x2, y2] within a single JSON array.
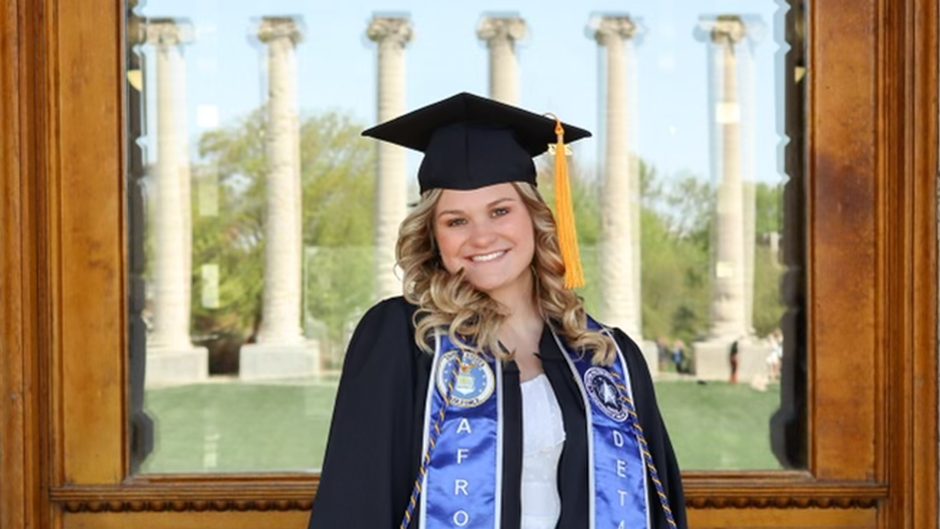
[[593, 16, 641, 339]]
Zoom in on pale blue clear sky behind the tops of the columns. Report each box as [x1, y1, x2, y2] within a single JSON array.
[[139, 0, 787, 186]]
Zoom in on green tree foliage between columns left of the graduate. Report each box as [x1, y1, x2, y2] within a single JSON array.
[[184, 108, 374, 348]]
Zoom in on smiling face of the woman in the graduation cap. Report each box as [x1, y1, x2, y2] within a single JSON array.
[[434, 183, 535, 298]]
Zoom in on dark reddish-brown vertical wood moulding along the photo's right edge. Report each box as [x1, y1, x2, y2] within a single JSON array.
[[880, 0, 938, 528]]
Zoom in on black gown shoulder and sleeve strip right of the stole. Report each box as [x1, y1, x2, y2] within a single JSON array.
[[612, 328, 688, 529]]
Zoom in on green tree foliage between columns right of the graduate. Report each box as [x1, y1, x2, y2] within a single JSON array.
[[564, 160, 783, 343]]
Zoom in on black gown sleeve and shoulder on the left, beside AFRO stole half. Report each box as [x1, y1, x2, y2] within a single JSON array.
[[309, 297, 431, 529]]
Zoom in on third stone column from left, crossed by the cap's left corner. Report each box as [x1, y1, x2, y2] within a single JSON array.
[[366, 16, 412, 299]]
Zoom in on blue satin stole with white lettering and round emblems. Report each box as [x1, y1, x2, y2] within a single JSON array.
[[414, 318, 650, 529]]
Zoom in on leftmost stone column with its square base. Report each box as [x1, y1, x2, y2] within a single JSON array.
[[141, 18, 209, 385]]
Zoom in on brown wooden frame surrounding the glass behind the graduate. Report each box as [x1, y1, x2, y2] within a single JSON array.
[[0, 0, 938, 529]]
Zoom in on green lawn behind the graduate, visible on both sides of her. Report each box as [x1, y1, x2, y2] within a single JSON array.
[[143, 381, 780, 472]]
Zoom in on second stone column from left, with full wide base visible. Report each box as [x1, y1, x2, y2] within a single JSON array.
[[239, 17, 319, 379]]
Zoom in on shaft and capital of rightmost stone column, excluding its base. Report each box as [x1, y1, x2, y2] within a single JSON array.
[[710, 16, 748, 339]]
